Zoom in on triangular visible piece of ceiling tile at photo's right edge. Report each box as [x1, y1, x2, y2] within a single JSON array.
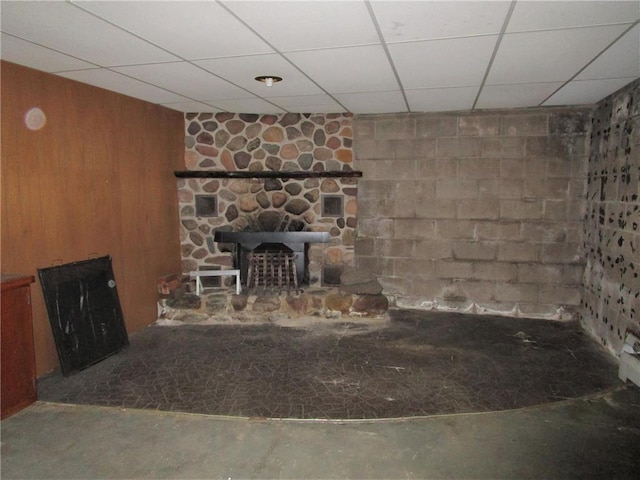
[[575, 25, 640, 80]]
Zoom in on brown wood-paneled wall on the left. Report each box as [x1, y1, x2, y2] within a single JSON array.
[[1, 62, 184, 375]]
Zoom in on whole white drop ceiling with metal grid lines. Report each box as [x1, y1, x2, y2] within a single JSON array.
[[0, 0, 640, 114]]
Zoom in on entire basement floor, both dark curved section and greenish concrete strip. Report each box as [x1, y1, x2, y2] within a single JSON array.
[[0, 311, 640, 479]]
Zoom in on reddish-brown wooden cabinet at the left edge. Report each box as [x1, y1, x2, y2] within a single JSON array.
[[0, 274, 37, 418]]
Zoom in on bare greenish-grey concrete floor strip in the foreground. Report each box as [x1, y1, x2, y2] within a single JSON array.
[[1, 384, 640, 479]]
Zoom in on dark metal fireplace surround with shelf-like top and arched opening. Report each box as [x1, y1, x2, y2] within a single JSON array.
[[213, 232, 331, 285]]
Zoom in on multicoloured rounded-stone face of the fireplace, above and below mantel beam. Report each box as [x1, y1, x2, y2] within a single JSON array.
[[178, 113, 357, 283]]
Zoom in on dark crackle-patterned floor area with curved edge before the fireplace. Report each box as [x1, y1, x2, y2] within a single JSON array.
[[38, 310, 621, 419]]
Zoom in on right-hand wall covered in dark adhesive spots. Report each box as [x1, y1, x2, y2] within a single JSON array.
[[582, 81, 640, 354]]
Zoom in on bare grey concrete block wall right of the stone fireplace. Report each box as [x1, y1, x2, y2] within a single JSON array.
[[354, 109, 589, 318]]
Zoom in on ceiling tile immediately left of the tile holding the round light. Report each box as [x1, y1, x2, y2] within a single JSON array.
[[113, 62, 252, 101]]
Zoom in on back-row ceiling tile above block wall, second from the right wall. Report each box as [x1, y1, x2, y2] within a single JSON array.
[[476, 82, 562, 109]]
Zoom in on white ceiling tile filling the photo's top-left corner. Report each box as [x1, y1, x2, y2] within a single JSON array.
[[2, 2, 176, 66]]
